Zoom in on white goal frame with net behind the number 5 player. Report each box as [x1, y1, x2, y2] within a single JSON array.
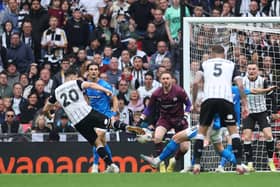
[[183, 17, 280, 171]]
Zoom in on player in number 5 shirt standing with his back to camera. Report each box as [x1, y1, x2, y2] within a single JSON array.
[[193, 45, 248, 174]]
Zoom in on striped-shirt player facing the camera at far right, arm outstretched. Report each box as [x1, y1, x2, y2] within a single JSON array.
[[243, 63, 277, 171]]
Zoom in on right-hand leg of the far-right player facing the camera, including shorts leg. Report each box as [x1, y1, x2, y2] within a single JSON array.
[[258, 112, 276, 171]]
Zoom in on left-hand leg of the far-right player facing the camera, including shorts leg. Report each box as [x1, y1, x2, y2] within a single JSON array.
[[243, 114, 256, 172]]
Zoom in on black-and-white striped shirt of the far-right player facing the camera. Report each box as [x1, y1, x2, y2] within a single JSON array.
[[243, 76, 267, 114]]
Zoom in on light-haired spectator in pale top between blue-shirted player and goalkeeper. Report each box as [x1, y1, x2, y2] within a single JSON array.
[[127, 90, 144, 115]]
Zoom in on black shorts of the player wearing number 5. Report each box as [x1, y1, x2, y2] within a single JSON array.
[[199, 99, 236, 126]]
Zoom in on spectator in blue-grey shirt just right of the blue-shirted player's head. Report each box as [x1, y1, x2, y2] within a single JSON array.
[[106, 57, 122, 87]]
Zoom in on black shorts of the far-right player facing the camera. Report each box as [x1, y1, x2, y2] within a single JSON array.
[[243, 112, 270, 131]]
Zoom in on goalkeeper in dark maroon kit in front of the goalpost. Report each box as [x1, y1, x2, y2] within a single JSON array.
[[138, 72, 191, 172]]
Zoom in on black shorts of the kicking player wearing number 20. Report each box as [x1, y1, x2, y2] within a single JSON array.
[[75, 110, 110, 145]]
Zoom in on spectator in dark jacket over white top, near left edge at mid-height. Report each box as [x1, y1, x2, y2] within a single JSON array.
[[11, 82, 27, 121]]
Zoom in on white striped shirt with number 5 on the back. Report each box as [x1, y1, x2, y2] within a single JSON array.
[[197, 58, 240, 102]]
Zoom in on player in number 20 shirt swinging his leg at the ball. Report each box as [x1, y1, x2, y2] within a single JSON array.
[[43, 69, 144, 173]]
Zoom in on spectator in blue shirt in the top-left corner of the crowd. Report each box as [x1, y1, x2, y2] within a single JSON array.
[[2, 0, 19, 30]]
